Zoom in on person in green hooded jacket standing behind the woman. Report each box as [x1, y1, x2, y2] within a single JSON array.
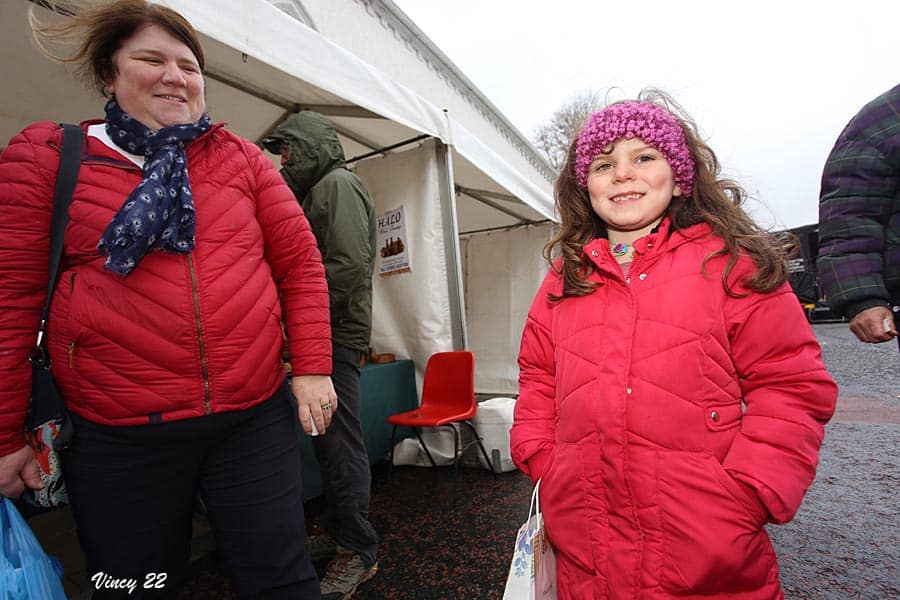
[[263, 111, 378, 600]]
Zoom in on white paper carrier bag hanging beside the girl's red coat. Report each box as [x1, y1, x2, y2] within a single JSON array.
[[503, 480, 556, 600]]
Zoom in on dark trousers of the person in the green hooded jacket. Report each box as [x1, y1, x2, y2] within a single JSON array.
[[312, 345, 378, 565]]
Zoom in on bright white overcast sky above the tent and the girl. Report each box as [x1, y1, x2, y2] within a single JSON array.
[[393, 0, 900, 227]]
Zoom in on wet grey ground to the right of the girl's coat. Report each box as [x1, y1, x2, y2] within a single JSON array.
[[768, 323, 900, 599]]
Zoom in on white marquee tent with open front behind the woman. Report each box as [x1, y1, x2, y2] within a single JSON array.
[[0, 0, 553, 393]]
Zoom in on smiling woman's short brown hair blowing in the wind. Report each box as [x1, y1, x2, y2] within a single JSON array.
[[29, 0, 206, 96]]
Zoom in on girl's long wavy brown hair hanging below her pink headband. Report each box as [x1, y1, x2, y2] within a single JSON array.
[[544, 89, 796, 300]]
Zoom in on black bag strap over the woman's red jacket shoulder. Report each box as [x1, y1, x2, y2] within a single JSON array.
[[34, 123, 84, 356]]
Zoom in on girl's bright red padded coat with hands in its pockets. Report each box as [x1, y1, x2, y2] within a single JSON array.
[[511, 223, 837, 600]]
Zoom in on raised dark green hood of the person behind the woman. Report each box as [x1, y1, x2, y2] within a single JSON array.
[[268, 111, 344, 202]]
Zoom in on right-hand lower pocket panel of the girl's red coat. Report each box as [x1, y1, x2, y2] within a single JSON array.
[[659, 452, 778, 594]]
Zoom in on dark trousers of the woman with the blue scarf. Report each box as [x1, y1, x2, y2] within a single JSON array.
[[63, 385, 320, 599]]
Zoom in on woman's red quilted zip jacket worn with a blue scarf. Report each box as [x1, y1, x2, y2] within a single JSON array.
[[0, 123, 331, 455]]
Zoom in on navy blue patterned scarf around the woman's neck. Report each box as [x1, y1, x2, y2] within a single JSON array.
[[97, 98, 210, 277]]
